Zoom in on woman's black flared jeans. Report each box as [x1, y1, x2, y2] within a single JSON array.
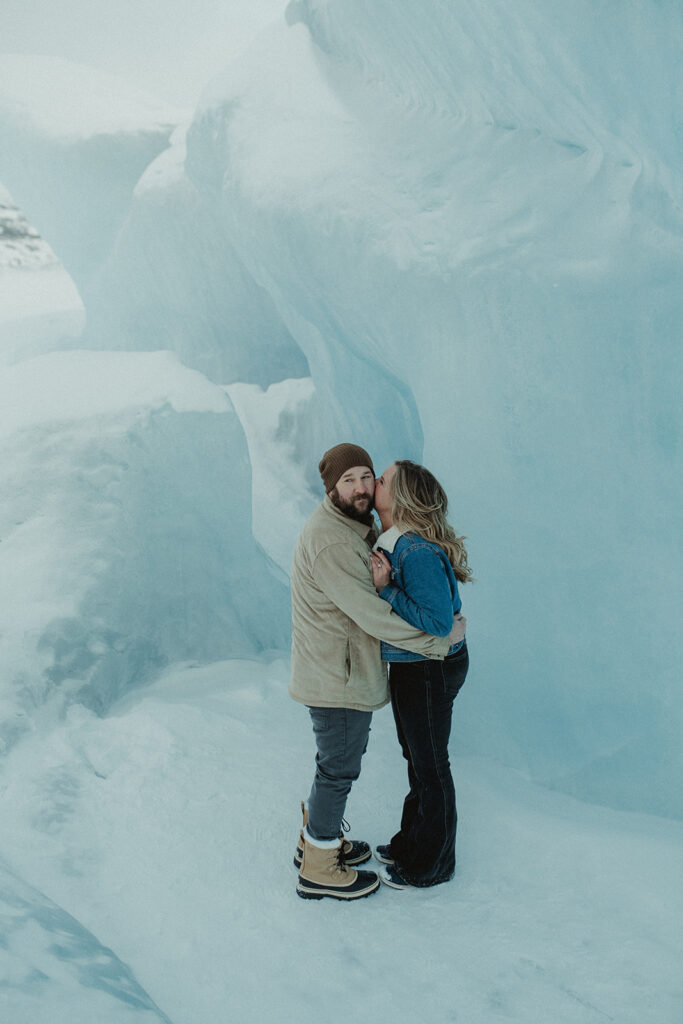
[[389, 642, 469, 886]]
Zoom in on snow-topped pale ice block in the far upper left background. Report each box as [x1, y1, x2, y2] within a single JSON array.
[[0, 55, 180, 292]]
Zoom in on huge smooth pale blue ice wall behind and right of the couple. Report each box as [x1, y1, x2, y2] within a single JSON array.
[[187, 0, 683, 813]]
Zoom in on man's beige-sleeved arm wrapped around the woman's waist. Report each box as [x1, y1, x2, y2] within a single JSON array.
[[313, 543, 451, 659]]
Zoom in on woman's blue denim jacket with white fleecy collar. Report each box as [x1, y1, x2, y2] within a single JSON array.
[[376, 526, 462, 662]]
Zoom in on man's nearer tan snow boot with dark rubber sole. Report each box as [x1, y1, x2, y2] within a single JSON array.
[[297, 828, 380, 899]]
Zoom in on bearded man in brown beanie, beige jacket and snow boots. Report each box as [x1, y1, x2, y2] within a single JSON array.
[[290, 443, 465, 899]]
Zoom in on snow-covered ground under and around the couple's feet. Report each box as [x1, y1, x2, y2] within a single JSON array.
[[0, 658, 683, 1024]]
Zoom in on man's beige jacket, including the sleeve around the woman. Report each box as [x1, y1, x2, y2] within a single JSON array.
[[290, 497, 449, 711]]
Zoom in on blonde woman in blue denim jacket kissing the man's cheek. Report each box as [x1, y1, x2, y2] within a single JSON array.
[[372, 460, 472, 889]]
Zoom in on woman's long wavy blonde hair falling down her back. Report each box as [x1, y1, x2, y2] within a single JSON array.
[[391, 459, 474, 583]]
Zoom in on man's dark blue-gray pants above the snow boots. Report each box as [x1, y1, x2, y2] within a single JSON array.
[[308, 708, 373, 840]]
